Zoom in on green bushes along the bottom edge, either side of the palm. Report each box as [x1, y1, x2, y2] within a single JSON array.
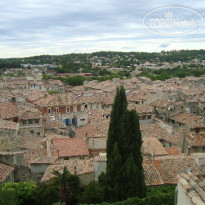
[[0, 180, 175, 205]]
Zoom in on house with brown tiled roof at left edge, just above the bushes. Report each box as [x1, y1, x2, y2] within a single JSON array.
[[0, 162, 15, 184]]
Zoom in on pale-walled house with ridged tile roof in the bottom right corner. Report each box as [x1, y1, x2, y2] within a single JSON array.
[[175, 169, 205, 205]]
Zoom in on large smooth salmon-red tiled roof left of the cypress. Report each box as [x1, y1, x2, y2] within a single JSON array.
[[53, 137, 89, 157]]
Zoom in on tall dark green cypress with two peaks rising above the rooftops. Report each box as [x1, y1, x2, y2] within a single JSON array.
[[105, 86, 145, 201]]
